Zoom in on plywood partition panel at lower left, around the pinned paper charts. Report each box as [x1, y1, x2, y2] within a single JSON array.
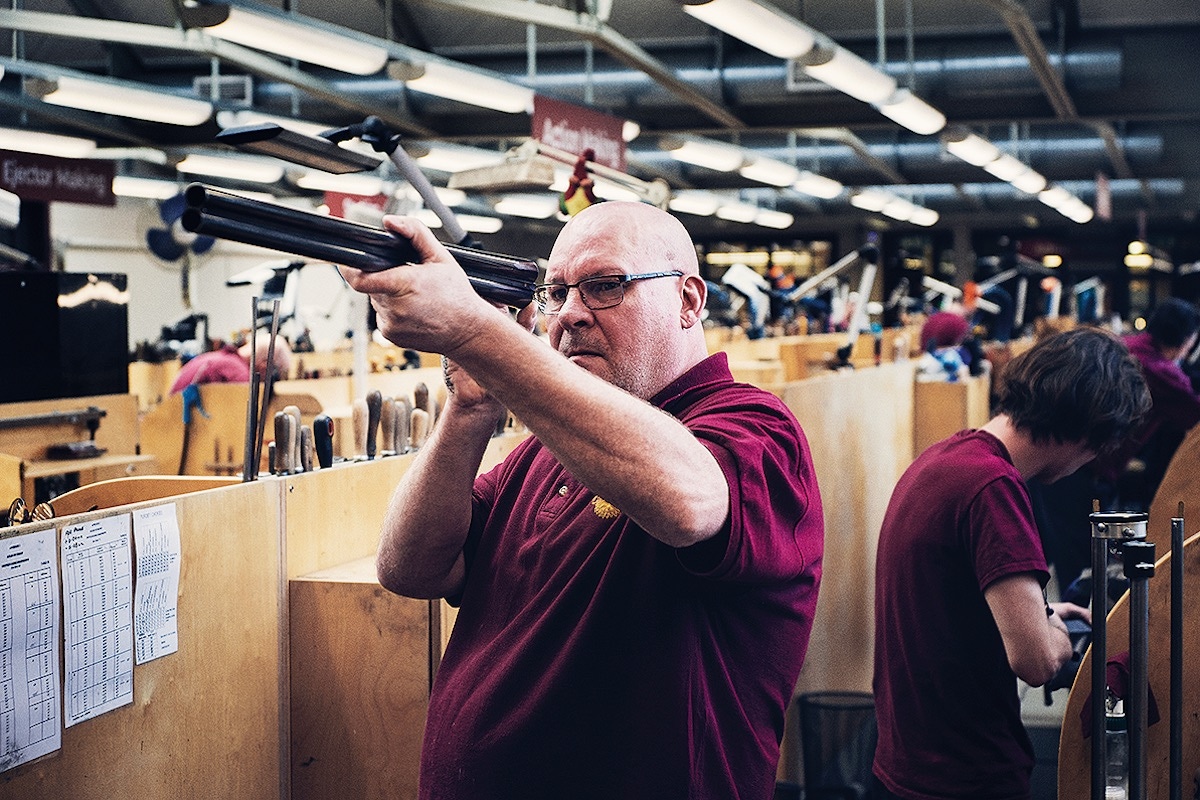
[[0, 482, 284, 800]]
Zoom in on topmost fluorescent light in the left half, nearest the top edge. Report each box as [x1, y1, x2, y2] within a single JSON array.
[[182, 0, 388, 76]]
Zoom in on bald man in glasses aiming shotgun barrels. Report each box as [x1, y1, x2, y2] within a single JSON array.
[[343, 201, 823, 800]]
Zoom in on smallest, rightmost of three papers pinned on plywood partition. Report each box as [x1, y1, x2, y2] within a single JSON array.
[[133, 504, 180, 664]]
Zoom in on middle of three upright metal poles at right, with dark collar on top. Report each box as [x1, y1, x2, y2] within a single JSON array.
[[1122, 541, 1154, 800]]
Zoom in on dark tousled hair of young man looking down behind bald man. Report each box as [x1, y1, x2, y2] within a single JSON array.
[[996, 327, 1150, 453]]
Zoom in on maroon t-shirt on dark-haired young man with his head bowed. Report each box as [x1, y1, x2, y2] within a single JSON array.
[[875, 431, 1049, 800]]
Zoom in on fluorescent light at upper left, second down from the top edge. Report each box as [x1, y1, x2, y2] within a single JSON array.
[[24, 76, 212, 126]]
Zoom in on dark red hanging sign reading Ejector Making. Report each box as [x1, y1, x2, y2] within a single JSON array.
[[0, 150, 116, 205]]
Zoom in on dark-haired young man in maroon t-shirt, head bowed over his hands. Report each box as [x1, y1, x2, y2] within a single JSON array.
[[874, 329, 1150, 800]]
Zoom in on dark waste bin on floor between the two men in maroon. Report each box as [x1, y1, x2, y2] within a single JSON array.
[[796, 692, 876, 800]]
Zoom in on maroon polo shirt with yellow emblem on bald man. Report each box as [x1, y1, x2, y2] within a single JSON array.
[[420, 354, 823, 800]]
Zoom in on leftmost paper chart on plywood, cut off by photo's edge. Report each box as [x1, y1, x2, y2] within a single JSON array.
[[0, 528, 62, 771]]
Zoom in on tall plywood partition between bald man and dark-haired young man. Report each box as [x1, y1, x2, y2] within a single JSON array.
[[782, 362, 914, 692]]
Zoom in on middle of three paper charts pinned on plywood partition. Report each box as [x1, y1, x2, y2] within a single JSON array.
[[62, 515, 133, 728]]
